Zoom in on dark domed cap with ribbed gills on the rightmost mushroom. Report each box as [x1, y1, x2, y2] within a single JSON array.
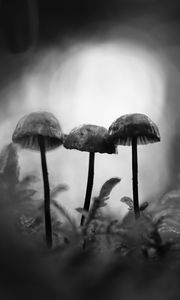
[[109, 113, 160, 146]]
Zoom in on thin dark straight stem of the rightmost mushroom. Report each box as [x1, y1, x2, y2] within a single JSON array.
[[132, 137, 140, 219]]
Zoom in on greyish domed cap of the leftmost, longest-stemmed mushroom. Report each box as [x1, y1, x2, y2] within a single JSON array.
[[12, 112, 63, 151]]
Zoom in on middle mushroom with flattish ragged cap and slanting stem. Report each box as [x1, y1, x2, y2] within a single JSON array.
[[64, 124, 116, 226]]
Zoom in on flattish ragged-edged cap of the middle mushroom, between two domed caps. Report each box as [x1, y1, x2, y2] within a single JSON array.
[[64, 124, 116, 154]]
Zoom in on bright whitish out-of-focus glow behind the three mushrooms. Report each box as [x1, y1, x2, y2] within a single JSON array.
[[0, 40, 170, 219]]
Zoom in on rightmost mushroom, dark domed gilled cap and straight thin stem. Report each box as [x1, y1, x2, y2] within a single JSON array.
[[109, 113, 160, 219]]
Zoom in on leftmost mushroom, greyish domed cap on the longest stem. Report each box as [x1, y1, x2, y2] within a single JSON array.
[[12, 112, 63, 248]]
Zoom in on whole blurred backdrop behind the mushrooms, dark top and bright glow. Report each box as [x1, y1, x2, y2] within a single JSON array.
[[0, 0, 180, 220]]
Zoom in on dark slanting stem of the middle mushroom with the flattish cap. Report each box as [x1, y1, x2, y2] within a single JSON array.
[[80, 152, 95, 226]]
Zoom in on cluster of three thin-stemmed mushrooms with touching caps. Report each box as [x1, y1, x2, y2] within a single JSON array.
[[12, 112, 160, 248]]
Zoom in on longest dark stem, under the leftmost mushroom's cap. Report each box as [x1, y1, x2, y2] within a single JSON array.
[[38, 135, 52, 248]]
